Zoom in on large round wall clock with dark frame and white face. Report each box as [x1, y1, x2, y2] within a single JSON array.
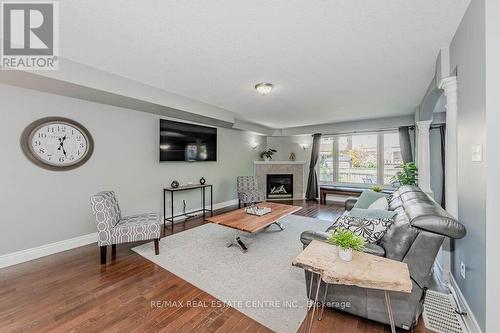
[[21, 117, 94, 171]]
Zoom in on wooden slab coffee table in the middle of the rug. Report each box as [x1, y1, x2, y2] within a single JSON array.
[[206, 202, 302, 252]]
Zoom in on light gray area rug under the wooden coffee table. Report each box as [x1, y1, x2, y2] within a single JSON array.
[[133, 215, 332, 333]]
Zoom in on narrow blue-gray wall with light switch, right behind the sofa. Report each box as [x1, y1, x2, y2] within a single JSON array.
[[450, 0, 484, 330]]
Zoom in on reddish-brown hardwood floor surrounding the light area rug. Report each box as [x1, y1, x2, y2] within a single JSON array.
[[0, 201, 427, 333]]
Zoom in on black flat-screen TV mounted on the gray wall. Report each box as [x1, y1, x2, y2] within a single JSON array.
[[160, 119, 217, 162]]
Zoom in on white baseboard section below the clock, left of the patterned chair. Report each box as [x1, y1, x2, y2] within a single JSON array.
[[0, 232, 97, 268]]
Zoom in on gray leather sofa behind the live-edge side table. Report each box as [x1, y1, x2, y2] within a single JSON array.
[[301, 186, 466, 329]]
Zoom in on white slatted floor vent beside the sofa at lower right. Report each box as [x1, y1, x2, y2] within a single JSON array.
[[423, 290, 468, 333]]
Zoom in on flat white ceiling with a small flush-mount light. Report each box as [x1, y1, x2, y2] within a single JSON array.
[[59, 0, 469, 128]]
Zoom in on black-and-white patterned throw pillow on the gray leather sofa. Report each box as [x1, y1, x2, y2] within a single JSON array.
[[335, 215, 393, 244]]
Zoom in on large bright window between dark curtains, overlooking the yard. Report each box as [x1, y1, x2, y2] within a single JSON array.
[[319, 132, 402, 185]]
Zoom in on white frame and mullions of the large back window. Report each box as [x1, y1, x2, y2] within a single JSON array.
[[316, 130, 397, 189]]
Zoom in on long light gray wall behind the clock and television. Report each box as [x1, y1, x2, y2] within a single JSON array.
[[0, 85, 265, 255]]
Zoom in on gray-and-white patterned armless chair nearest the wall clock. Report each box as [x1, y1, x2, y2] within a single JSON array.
[[90, 191, 161, 264]]
